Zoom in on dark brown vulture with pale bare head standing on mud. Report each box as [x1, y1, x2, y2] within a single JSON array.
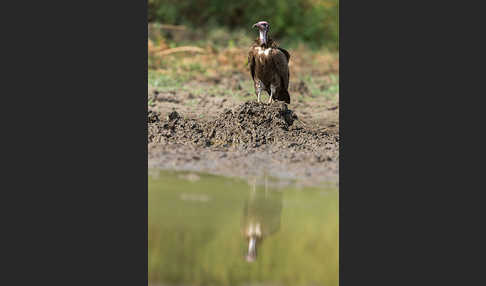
[[248, 21, 290, 103]]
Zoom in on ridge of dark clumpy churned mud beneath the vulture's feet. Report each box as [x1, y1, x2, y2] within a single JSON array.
[[148, 101, 332, 150]]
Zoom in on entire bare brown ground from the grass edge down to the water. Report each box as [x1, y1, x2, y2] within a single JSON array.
[[147, 74, 339, 185]]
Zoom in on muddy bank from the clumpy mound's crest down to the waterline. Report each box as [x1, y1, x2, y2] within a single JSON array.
[[148, 101, 339, 185]]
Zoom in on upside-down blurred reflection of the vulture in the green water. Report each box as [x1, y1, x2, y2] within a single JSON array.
[[242, 178, 282, 262]]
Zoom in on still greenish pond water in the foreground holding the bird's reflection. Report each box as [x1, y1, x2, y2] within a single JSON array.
[[148, 172, 339, 286]]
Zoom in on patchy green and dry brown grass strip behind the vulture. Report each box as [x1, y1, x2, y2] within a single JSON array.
[[148, 29, 339, 104]]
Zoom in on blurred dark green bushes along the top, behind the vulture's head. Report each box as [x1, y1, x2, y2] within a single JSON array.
[[148, 0, 339, 50]]
